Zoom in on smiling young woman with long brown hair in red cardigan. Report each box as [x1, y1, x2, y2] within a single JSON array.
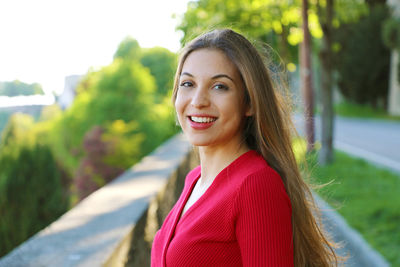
[[151, 29, 337, 267]]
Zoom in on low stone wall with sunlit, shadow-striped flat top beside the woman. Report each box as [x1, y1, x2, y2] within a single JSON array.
[[0, 135, 196, 267]]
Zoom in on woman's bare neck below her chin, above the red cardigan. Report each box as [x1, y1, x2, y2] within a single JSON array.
[[199, 144, 250, 184]]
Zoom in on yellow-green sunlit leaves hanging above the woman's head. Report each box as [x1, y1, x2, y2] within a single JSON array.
[[177, 0, 367, 70]]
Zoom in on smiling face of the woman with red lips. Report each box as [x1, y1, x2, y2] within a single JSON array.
[[175, 49, 250, 153]]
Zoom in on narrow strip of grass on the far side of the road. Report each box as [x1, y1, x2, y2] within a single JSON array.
[[335, 102, 400, 121]]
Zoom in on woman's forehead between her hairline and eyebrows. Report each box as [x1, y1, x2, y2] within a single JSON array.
[[181, 48, 239, 78]]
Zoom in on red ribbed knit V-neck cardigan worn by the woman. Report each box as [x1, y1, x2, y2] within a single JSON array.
[[151, 151, 293, 267]]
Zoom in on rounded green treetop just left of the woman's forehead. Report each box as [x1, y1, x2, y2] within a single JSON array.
[[140, 47, 177, 99]]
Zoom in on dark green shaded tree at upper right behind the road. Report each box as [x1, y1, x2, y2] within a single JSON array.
[[333, 5, 390, 107]]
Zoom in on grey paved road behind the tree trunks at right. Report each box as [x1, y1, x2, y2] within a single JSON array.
[[294, 115, 400, 173]]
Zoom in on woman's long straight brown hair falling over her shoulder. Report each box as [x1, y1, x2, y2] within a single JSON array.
[[172, 29, 338, 267]]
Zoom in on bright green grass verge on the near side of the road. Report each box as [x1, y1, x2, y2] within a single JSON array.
[[302, 151, 400, 266]]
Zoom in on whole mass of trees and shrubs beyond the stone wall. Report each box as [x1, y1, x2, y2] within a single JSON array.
[[0, 38, 178, 256]]
